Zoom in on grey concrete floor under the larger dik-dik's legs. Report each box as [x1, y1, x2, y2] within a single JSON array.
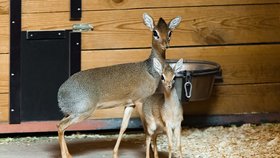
[[0, 132, 168, 158]]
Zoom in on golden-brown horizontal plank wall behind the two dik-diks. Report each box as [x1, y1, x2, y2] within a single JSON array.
[[0, 0, 280, 122]]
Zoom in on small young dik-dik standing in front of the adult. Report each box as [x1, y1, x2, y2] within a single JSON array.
[[142, 59, 183, 158]]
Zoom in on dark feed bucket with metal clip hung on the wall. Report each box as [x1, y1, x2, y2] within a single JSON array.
[[166, 60, 222, 102]]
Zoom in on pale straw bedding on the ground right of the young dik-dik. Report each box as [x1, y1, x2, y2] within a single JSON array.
[[159, 124, 280, 158]]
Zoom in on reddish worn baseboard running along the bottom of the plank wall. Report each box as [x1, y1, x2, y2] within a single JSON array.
[[0, 113, 280, 134]]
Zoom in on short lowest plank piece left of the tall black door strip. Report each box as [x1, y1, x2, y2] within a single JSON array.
[[0, 94, 9, 122]]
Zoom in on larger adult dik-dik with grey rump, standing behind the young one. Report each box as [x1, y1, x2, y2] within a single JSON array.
[[58, 14, 181, 158]]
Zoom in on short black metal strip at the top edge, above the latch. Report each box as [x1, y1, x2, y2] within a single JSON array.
[[70, 0, 82, 20]]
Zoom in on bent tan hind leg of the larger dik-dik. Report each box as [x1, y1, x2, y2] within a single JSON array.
[[57, 113, 91, 158]]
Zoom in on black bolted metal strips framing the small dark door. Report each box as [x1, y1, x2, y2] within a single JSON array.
[[9, 0, 81, 124]]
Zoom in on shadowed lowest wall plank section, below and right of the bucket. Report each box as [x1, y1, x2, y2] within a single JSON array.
[[184, 83, 280, 115]]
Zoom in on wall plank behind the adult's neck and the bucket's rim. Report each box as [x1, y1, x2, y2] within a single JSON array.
[[82, 44, 280, 84]]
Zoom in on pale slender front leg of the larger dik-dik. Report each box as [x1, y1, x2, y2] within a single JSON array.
[[113, 106, 134, 158]]
